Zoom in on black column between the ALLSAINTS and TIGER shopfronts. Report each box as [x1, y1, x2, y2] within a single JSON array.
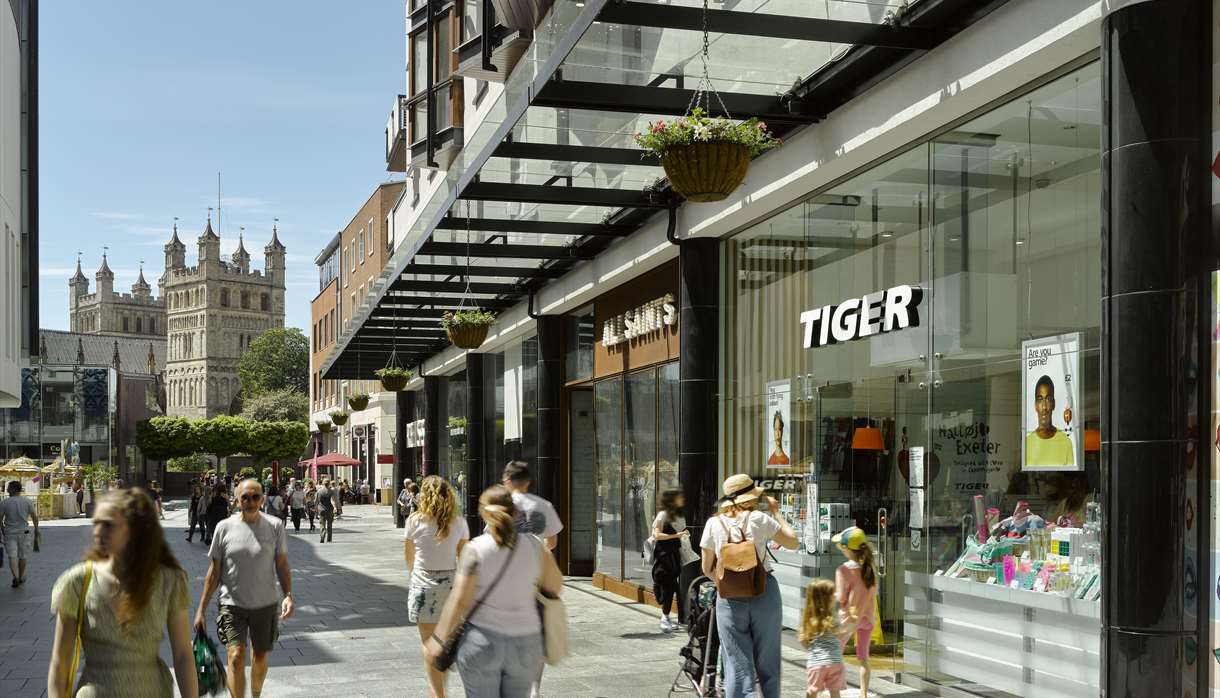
[[678, 239, 720, 529]]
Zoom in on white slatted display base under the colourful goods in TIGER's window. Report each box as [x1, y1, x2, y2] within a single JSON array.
[[904, 571, 1102, 698]]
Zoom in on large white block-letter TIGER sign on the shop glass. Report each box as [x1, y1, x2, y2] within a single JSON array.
[[800, 284, 924, 349]]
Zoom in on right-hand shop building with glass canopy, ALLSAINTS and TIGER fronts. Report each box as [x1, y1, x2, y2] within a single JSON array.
[[320, 0, 1220, 698]]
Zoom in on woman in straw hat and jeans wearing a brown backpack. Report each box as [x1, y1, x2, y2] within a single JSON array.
[[699, 473, 798, 698]]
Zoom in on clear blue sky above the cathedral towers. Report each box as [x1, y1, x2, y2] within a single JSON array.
[[39, 0, 405, 331]]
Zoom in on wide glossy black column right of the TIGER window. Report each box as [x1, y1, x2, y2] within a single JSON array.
[[1102, 0, 1214, 698]]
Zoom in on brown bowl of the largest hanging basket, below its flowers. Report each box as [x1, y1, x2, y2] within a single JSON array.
[[661, 142, 750, 203]]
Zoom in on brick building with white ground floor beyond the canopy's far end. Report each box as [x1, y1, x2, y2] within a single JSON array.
[[310, 181, 404, 487]]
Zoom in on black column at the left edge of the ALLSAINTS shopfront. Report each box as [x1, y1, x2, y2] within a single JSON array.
[[532, 315, 566, 507]]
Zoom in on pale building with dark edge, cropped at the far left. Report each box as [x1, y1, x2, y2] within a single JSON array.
[[0, 0, 38, 408]]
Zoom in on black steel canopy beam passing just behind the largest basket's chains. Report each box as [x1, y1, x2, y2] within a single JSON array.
[[533, 79, 822, 123]]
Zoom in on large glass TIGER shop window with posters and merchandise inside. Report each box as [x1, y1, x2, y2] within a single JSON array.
[[721, 65, 1102, 696]]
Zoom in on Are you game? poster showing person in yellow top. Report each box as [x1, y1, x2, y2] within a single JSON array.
[[1021, 332, 1085, 471]]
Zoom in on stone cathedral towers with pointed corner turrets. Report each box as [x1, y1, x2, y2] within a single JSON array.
[[68, 217, 285, 419]]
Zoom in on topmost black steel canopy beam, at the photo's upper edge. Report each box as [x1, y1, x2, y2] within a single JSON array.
[[598, 1, 944, 51]]
